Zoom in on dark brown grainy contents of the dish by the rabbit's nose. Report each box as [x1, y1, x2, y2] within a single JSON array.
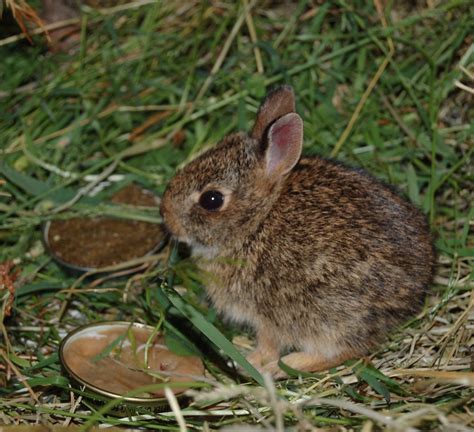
[[48, 184, 165, 269]]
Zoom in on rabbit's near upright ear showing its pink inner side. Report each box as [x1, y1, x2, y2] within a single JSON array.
[[265, 113, 303, 176]]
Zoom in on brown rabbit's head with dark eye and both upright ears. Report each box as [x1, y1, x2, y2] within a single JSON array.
[[161, 86, 303, 257]]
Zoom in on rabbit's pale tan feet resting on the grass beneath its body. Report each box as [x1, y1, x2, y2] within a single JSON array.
[[261, 352, 352, 379]]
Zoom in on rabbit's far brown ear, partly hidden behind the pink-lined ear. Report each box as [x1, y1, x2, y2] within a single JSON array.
[[251, 86, 295, 141]]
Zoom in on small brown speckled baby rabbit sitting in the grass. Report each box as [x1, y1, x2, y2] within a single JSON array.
[[161, 86, 435, 378]]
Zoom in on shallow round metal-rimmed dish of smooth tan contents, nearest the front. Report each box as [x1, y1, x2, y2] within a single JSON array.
[[59, 321, 204, 406]]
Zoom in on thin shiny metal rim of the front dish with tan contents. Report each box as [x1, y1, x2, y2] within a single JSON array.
[[58, 320, 200, 406]]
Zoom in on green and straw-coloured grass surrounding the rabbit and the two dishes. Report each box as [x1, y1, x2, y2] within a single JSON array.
[[0, 0, 474, 431]]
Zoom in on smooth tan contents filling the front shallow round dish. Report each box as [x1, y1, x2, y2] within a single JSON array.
[[63, 325, 204, 397]]
